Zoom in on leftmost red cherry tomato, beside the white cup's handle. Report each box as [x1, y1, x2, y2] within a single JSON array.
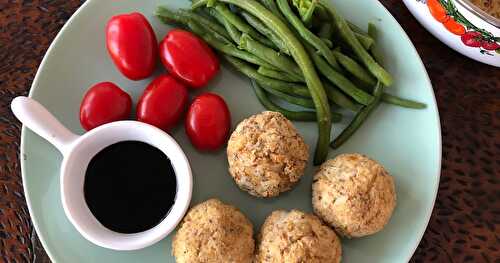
[[80, 82, 132, 131]]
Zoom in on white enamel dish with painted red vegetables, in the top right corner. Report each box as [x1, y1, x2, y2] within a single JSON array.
[[403, 0, 500, 67]]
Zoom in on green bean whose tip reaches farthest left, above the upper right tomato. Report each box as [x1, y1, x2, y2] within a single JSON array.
[[156, 6, 231, 41]]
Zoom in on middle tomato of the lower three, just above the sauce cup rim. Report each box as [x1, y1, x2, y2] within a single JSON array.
[[137, 75, 188, 131]]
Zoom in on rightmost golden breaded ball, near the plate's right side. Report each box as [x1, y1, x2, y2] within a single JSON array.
[[312, 154, 396, 238]]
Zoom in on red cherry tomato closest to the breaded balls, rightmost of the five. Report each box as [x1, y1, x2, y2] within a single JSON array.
[[185, 93, 231, 150]]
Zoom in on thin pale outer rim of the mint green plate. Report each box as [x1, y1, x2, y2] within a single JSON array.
[[19, 0, 443, 262]]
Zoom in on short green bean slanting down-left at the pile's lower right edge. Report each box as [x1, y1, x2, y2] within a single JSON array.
[[330, 82, 384, 149]]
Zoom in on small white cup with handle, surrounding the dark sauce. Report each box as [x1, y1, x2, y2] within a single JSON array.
[[12, 97, 193, 250]]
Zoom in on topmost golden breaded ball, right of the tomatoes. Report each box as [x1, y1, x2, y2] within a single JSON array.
[[227, 111, 309, 197]]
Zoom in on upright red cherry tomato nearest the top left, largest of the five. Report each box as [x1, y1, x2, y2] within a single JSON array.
[[106, 13, 158, 80]]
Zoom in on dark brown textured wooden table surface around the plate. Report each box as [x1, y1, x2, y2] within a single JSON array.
[[0, 0, 500, 263]]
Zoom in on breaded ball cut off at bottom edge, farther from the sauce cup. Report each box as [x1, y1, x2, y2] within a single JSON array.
[[255, 210, 342, 263]]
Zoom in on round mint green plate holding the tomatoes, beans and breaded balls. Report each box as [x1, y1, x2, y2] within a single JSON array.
[[21, 0, 441, 263]]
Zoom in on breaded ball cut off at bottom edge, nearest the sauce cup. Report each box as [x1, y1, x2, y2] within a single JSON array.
[[172, 199, 255, 263]]
